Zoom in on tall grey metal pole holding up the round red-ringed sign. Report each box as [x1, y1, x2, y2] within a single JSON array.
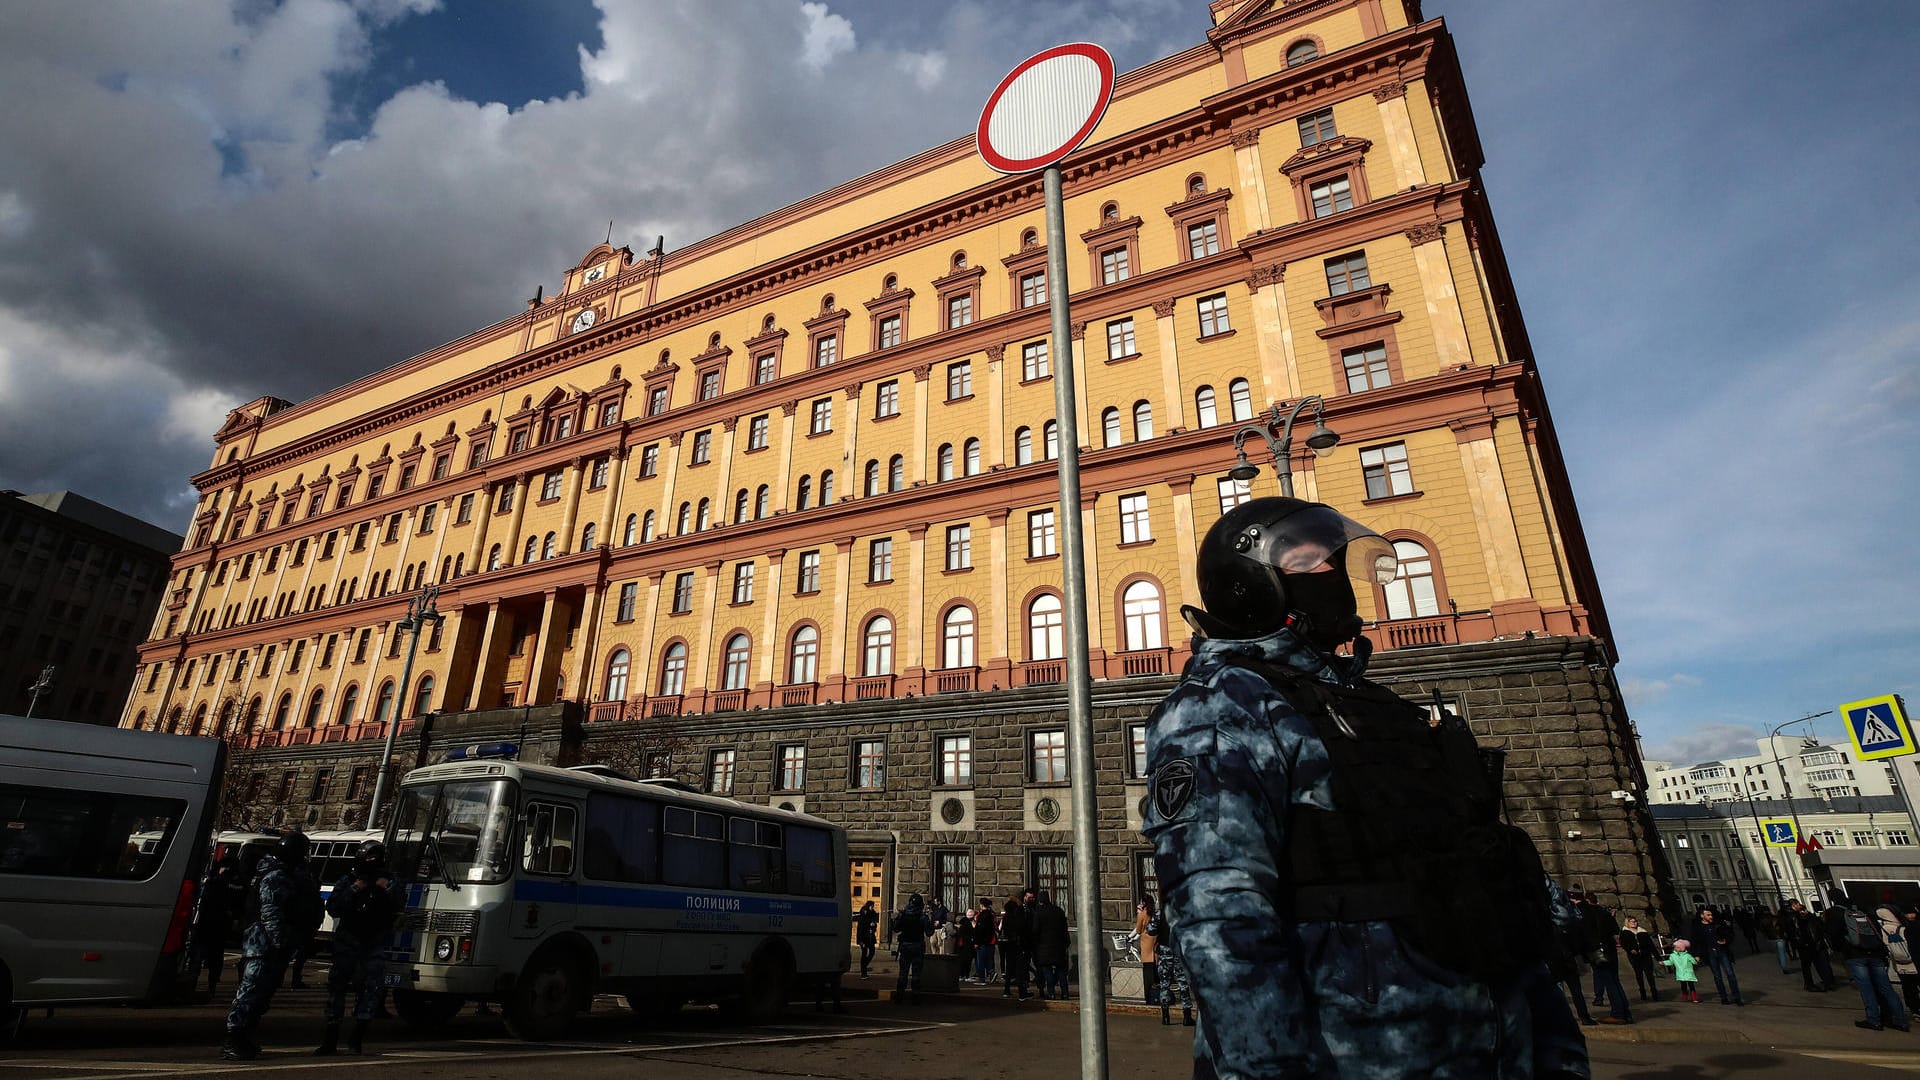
[[1044, 165, 1106, 1080]]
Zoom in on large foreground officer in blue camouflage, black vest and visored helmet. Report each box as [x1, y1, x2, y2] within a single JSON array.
[[1144, 498, 1590, 1080]]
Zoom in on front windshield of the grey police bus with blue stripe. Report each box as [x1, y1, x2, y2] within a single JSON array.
[[386, 778, 515, 886]]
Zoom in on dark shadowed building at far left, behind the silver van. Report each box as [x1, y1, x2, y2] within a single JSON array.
[[0, 492, 182, 724]]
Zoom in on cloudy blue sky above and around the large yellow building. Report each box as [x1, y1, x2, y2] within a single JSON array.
[[0, 0, 1920, 759]]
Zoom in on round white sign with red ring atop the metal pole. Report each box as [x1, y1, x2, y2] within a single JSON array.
[[973, 42, 1114, 173]]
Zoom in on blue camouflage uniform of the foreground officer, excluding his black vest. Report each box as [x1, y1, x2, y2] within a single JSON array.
[[1144, 628, 1590, 1080]]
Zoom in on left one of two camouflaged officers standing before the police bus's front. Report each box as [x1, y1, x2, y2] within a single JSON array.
[[221, 830, 321, 1061]]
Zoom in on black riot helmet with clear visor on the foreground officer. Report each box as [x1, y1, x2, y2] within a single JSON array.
[[1187, 498, 1398, 648]]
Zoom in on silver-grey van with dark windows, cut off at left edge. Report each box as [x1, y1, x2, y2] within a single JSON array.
[[0, 717, 227, 1030]]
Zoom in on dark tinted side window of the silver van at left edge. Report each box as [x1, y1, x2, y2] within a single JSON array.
[[0, 784, 186, 880]]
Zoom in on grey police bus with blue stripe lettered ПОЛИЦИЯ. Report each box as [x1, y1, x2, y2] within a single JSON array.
[[386, 761, 851, 1040]]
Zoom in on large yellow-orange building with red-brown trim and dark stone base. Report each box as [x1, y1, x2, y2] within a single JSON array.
[[123, 0, 1665, 922]]
